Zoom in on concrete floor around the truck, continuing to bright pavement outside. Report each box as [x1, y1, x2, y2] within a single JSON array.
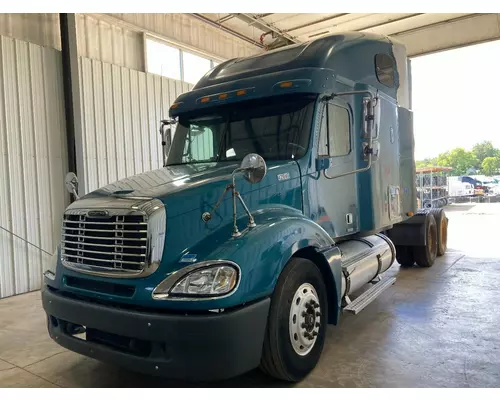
[[0, 204, 500, 387]]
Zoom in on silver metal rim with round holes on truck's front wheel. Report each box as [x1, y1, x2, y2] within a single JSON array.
[[288, 283, 321, 356]]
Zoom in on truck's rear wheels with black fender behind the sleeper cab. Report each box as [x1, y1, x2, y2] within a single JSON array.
[[388, 208, 448, 268]]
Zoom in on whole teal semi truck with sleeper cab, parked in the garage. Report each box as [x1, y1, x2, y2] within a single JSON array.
[[42, 32, 448, 382]]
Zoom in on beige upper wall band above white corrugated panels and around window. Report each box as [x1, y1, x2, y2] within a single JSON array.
[[0, 13, 260, 71]]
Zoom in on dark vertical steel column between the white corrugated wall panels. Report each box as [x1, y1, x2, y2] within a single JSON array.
[[59, 14, 86, 196]]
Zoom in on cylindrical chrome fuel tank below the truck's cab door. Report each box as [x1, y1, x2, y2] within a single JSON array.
[[338, 233, 396, 297]]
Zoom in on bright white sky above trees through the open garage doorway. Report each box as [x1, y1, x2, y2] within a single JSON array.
[[411, 41, 500, 160]]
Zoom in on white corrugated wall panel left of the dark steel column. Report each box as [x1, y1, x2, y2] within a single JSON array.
[[0, 36, 69, 297]]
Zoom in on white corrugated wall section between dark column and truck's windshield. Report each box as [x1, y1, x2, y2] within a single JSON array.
[[80, 57, 192, 192]]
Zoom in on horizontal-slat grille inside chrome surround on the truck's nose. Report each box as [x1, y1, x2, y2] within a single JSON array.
[[62, 210, 148, 273]]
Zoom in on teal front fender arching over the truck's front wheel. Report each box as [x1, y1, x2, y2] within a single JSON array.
[[193, 207, 342, 323]]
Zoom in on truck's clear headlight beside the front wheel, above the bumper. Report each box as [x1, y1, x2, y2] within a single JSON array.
[[153, 261, 240, 300]]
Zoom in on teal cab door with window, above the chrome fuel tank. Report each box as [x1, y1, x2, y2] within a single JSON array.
[[317, 98, 359, 238]]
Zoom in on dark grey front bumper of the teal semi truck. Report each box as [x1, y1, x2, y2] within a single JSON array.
[[42, 286, 270, 381]]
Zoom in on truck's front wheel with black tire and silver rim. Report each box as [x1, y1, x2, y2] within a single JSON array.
[[261, 258, 328, 382]]
